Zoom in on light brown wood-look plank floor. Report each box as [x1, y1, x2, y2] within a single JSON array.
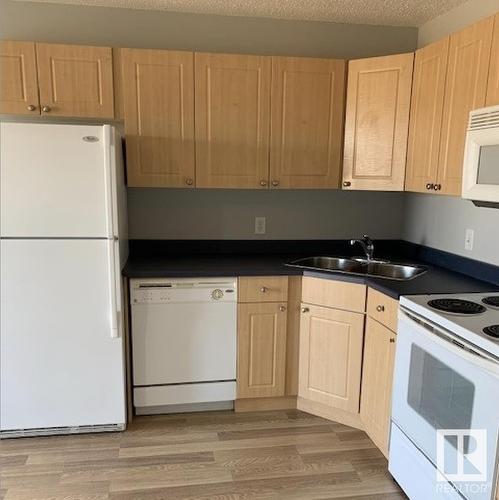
[[0, 410, 406, 500]]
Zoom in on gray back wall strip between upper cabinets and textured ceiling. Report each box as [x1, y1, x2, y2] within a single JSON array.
[[0, 0, 417, 58]]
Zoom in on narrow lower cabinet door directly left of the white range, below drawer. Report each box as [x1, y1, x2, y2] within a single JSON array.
[[360, 318, 396, 456]]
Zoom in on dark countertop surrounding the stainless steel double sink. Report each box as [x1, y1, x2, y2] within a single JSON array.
[[123, 242, 499, 299]]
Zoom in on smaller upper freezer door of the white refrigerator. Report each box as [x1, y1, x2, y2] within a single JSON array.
[[0, 123, 117, 238]]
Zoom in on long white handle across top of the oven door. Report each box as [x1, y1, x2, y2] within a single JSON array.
[[399, 309, 499, 378]]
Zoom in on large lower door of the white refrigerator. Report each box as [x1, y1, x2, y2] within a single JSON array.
[[0, 240, 125, 430]]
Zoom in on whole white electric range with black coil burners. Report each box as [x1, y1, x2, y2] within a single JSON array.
[[389, 292, 499, 500]]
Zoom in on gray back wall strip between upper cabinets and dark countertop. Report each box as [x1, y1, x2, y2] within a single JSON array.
[[128, 188, 404, 239]]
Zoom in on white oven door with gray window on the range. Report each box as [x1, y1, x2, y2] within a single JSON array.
[[392, 309, 499, 500]]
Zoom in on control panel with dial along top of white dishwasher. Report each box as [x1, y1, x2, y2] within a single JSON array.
[[130, 278, 237, 305]]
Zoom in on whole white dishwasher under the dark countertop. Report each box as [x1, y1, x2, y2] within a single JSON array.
[[130, 278, 237, 415]]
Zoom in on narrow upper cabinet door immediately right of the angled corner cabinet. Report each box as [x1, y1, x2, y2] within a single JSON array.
[[405, 37, 449, 193]]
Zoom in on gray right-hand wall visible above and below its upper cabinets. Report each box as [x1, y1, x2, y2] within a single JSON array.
[[403, 0, 499, 265]]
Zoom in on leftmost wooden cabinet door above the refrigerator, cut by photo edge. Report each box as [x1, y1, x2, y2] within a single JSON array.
[[0, 42, 40, 115]]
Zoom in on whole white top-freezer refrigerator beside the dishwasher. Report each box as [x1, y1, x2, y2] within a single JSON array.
[[0, 122, 127, 437]]
